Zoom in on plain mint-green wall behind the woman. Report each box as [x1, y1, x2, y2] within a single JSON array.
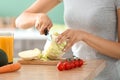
[[0, 0, 64, 24]]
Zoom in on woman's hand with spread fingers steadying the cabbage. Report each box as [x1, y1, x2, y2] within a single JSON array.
[[56, 29, 85, 52]]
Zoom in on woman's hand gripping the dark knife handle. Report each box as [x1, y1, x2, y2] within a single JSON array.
[[35, 13, 53, 34]]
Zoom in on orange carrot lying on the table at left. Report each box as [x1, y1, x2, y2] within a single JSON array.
[[0, 63, 21, 74]]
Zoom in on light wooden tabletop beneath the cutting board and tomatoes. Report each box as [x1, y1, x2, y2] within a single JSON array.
[[0, 60, 105, 80]]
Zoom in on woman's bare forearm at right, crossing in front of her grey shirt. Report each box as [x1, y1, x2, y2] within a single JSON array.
[[83, 33, 120, 59]]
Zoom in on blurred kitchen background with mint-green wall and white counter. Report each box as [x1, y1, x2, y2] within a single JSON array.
[[0, 0, 72, 57]]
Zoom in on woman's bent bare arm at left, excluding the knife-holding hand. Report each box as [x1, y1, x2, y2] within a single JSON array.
[[16, 0, 60, 29]]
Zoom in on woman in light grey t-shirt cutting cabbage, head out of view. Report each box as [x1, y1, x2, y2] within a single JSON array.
[[16, 0, 120, 80]]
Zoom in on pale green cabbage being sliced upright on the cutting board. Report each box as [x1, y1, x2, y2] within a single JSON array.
[[43, 33, 66, 59]]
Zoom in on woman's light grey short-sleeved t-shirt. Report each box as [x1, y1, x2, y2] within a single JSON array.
[[63, 0, 120, 80]]
